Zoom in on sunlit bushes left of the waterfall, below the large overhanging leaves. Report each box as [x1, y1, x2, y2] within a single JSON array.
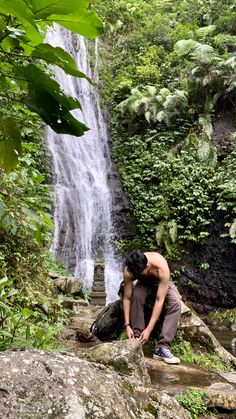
[[0, 104, 69, 349]]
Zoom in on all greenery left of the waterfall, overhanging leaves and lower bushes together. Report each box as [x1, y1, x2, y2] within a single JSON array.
[[0, 0, 102, 350]]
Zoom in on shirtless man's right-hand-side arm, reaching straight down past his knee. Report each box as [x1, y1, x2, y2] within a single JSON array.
[[140, 264, 170, 343]]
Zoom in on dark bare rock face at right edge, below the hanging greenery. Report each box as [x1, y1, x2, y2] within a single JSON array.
[[175, 213, 236, 313]]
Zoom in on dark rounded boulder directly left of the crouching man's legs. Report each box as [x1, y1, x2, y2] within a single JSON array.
[[90, 300, 124, 342]]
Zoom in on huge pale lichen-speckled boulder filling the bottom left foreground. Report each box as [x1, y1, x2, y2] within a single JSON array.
[[0, 347, 190, 419]]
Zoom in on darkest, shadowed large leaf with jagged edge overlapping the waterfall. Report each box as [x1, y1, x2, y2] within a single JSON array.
[[25, 85, 88, 137]]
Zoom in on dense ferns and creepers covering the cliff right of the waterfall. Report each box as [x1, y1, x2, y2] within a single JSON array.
[[96, 0, 236, 260]]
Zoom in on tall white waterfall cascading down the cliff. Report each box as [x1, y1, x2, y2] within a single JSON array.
[[46, 25, 122, 303]]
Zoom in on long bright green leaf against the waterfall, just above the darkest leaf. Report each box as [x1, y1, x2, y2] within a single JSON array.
[[31, 44, 92, 84]]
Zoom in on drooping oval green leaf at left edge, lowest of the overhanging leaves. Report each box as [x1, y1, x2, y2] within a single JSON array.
[[0, 117, 22, 172]]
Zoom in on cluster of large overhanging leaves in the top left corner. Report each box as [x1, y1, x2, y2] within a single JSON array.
[[0, 0, 102, 172]]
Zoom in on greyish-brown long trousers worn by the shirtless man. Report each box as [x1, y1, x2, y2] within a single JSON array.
[[130, 281, 181, 348]]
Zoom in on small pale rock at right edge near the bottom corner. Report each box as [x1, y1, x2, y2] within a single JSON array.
[[204, 383, 236, 413]]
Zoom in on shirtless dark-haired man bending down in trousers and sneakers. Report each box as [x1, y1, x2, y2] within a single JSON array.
[[123, 250, 181, 364]]
